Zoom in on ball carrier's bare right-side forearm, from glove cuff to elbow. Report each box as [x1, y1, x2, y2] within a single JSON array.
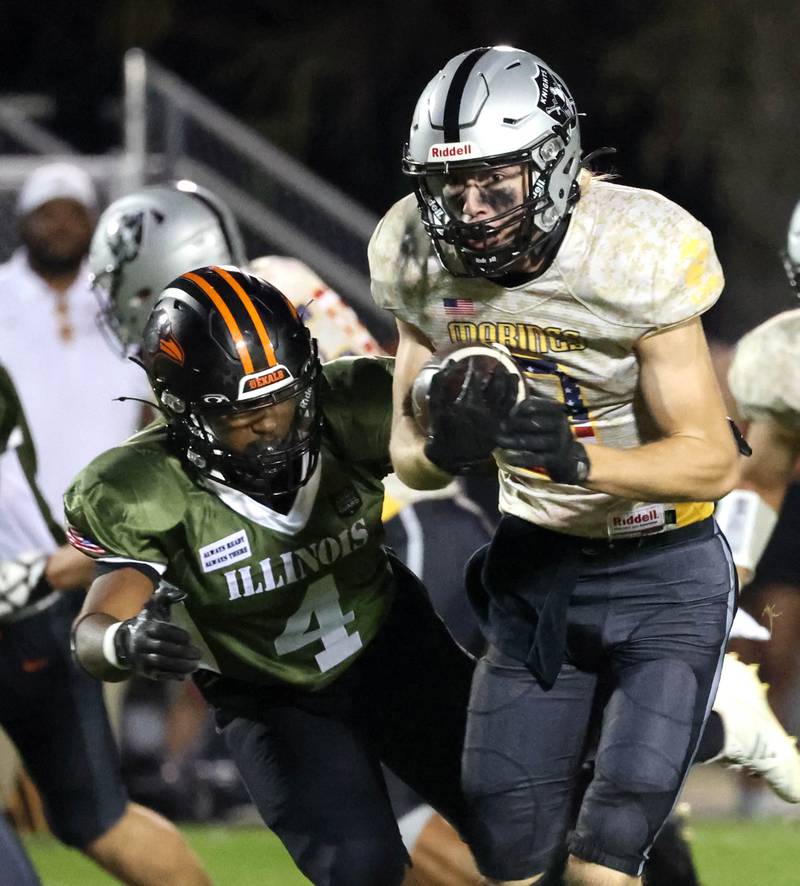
[[584, 435, 738, 502]]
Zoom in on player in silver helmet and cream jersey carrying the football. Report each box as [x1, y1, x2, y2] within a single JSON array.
[[370, 47, 748, 884]]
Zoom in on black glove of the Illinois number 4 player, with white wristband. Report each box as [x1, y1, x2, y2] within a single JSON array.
[[114, 585, 201, 680]]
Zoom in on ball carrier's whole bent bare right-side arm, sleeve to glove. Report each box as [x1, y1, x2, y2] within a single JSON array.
[[585, 319, 738, 501]]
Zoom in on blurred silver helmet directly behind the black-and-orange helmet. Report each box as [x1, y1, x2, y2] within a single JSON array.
[[89, 181, 246, 356]]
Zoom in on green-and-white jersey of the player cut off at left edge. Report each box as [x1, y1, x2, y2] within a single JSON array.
[[0, 367, 64, 560]]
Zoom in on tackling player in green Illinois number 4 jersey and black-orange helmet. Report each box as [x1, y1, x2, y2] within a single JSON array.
[[65, 267, 473, 886]]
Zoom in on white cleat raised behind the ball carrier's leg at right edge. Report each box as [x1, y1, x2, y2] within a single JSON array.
[[714, 653, 800, 803]]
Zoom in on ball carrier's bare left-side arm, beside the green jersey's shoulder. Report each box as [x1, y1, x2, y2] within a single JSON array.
[[389, 320, 452, 489]]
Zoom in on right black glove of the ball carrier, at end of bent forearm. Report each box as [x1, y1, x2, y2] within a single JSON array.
[[496, 397, 589, 486]]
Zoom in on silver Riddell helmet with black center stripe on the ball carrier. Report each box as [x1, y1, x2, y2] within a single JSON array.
[[403, 46, 581, 277]]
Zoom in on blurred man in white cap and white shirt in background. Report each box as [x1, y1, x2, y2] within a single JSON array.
[[0, 163, 146, 520]]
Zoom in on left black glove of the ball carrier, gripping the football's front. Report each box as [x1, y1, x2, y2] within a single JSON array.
[[425, 357, 519, 474]]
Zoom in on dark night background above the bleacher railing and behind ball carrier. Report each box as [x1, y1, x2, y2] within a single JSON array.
[[0, 0, 800, 339]]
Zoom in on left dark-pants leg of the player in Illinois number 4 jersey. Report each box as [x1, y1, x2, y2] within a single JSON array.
[[223, 712, 408, 886]]
